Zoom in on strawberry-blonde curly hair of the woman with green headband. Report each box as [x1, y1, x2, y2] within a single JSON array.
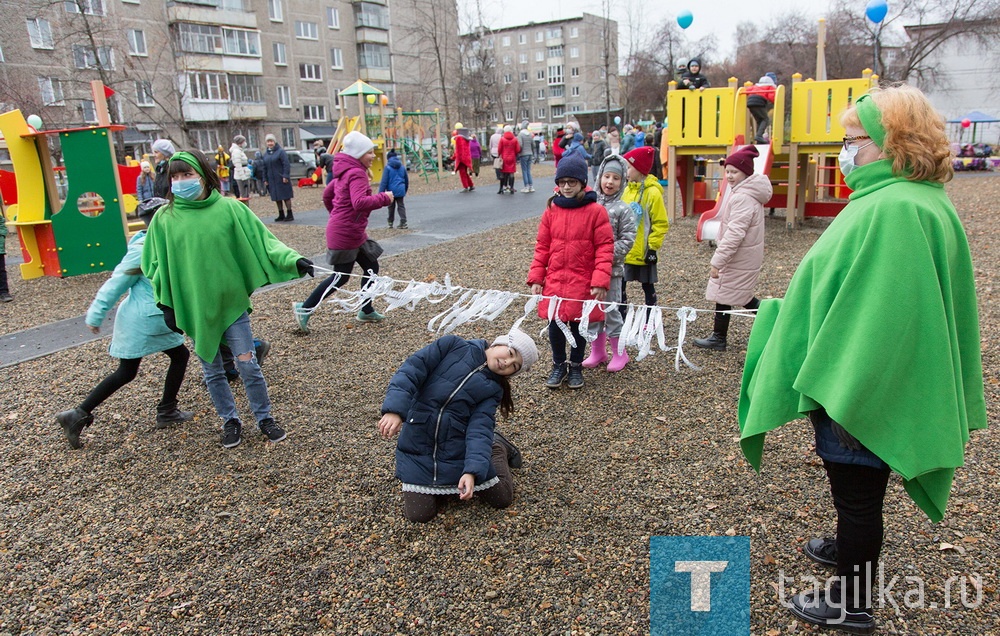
[[840, 84, 955, 183]]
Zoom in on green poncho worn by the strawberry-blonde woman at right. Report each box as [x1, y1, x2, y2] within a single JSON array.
[[739, 160, 986, 521]]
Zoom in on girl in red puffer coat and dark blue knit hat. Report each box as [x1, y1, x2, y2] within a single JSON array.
[[528, 157, 615, 389]]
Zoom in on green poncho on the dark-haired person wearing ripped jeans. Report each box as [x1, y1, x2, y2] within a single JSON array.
[[142, 191, 302, 361]]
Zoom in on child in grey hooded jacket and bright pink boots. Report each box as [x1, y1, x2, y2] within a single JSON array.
[[583, 155, 635, 373]]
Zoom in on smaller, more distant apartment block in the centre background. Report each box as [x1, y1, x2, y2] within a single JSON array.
[[461, 13, 619, 125]]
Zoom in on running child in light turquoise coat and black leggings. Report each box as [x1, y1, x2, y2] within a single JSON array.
[[56, 198, 194, 448]]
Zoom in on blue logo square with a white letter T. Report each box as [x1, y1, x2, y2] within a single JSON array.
[[649, 537, 750, 636]]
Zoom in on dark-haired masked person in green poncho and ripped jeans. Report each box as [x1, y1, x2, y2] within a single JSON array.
[[142, 150, 313, 448]]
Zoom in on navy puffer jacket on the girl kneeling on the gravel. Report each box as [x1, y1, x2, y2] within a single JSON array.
[[382, 335, 503, 487]]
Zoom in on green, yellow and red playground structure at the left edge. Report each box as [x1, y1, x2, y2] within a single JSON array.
[[0, 81, 135, 280]]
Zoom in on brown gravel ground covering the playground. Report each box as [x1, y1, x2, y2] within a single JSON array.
[[0, 175, 1000, 636]]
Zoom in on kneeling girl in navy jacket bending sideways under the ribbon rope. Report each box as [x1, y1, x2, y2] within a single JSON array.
[[378, 328, 538, 523]]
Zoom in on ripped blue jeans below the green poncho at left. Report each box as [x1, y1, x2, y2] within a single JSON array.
[[201, 312, 271, 422]]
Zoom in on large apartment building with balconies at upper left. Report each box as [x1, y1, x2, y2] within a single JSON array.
[[0, 0, 458, 155]]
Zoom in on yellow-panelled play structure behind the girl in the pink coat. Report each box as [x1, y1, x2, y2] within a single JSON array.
[[664, 69, 878, 231]]
